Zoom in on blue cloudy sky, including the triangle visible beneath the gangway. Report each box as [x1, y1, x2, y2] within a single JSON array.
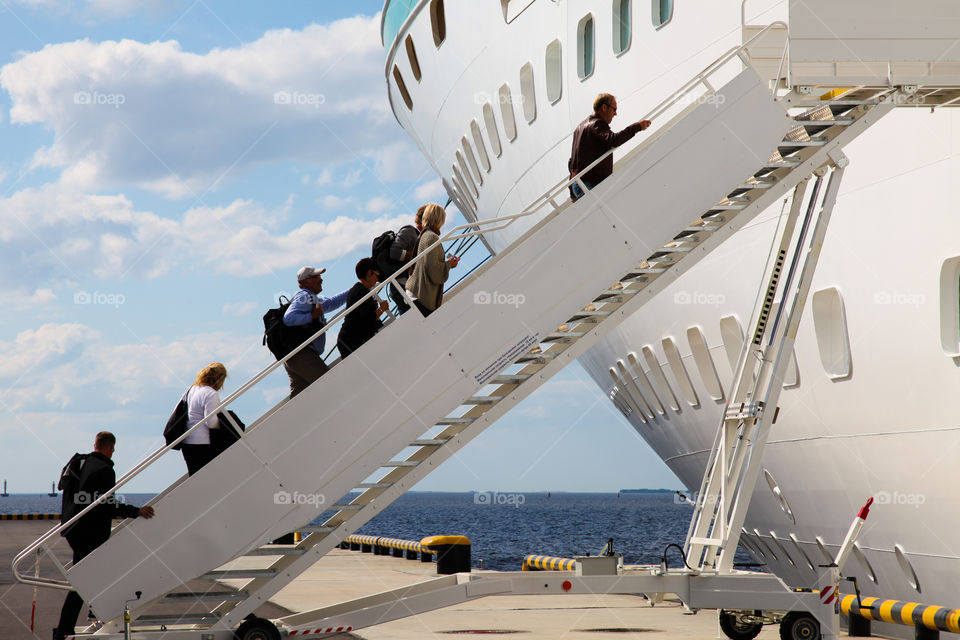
[[0, 0, 680, 493]]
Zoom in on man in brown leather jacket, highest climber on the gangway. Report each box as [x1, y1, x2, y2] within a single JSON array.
[[567, 93, 650, 202]]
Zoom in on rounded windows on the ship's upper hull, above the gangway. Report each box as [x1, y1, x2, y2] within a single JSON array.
[[442, 0, 673, 218]]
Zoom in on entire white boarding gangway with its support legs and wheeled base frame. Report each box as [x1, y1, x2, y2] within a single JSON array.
[[13, 0, 960, 640]]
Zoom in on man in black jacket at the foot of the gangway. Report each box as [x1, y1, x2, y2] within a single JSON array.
[[53, 431, 153, 640]]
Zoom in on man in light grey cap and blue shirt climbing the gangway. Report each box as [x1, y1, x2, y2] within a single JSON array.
[[283, 267, 350, 398]]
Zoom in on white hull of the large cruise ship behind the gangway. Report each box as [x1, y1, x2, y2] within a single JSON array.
[[386, 0, 960, 634]]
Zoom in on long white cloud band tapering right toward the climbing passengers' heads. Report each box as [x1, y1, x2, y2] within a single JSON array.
[[0, 184, 402, 300]]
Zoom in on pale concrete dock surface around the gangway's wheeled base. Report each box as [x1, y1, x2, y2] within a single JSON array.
[[0, 521, 779, 640]]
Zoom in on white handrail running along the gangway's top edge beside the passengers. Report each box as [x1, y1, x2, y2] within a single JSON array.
[[11, 21, 787, 589]]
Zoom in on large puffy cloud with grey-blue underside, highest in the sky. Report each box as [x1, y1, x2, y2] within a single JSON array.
[[0, 16, 427, 197]]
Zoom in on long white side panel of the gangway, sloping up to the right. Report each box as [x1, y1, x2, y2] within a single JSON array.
[[69, 70, 791, 619]]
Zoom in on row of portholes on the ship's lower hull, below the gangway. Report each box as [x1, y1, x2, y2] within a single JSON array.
[[609, 287, 852, 423]]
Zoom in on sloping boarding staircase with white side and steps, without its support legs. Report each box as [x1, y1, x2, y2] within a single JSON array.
[[14, 21, 916, 638]]
